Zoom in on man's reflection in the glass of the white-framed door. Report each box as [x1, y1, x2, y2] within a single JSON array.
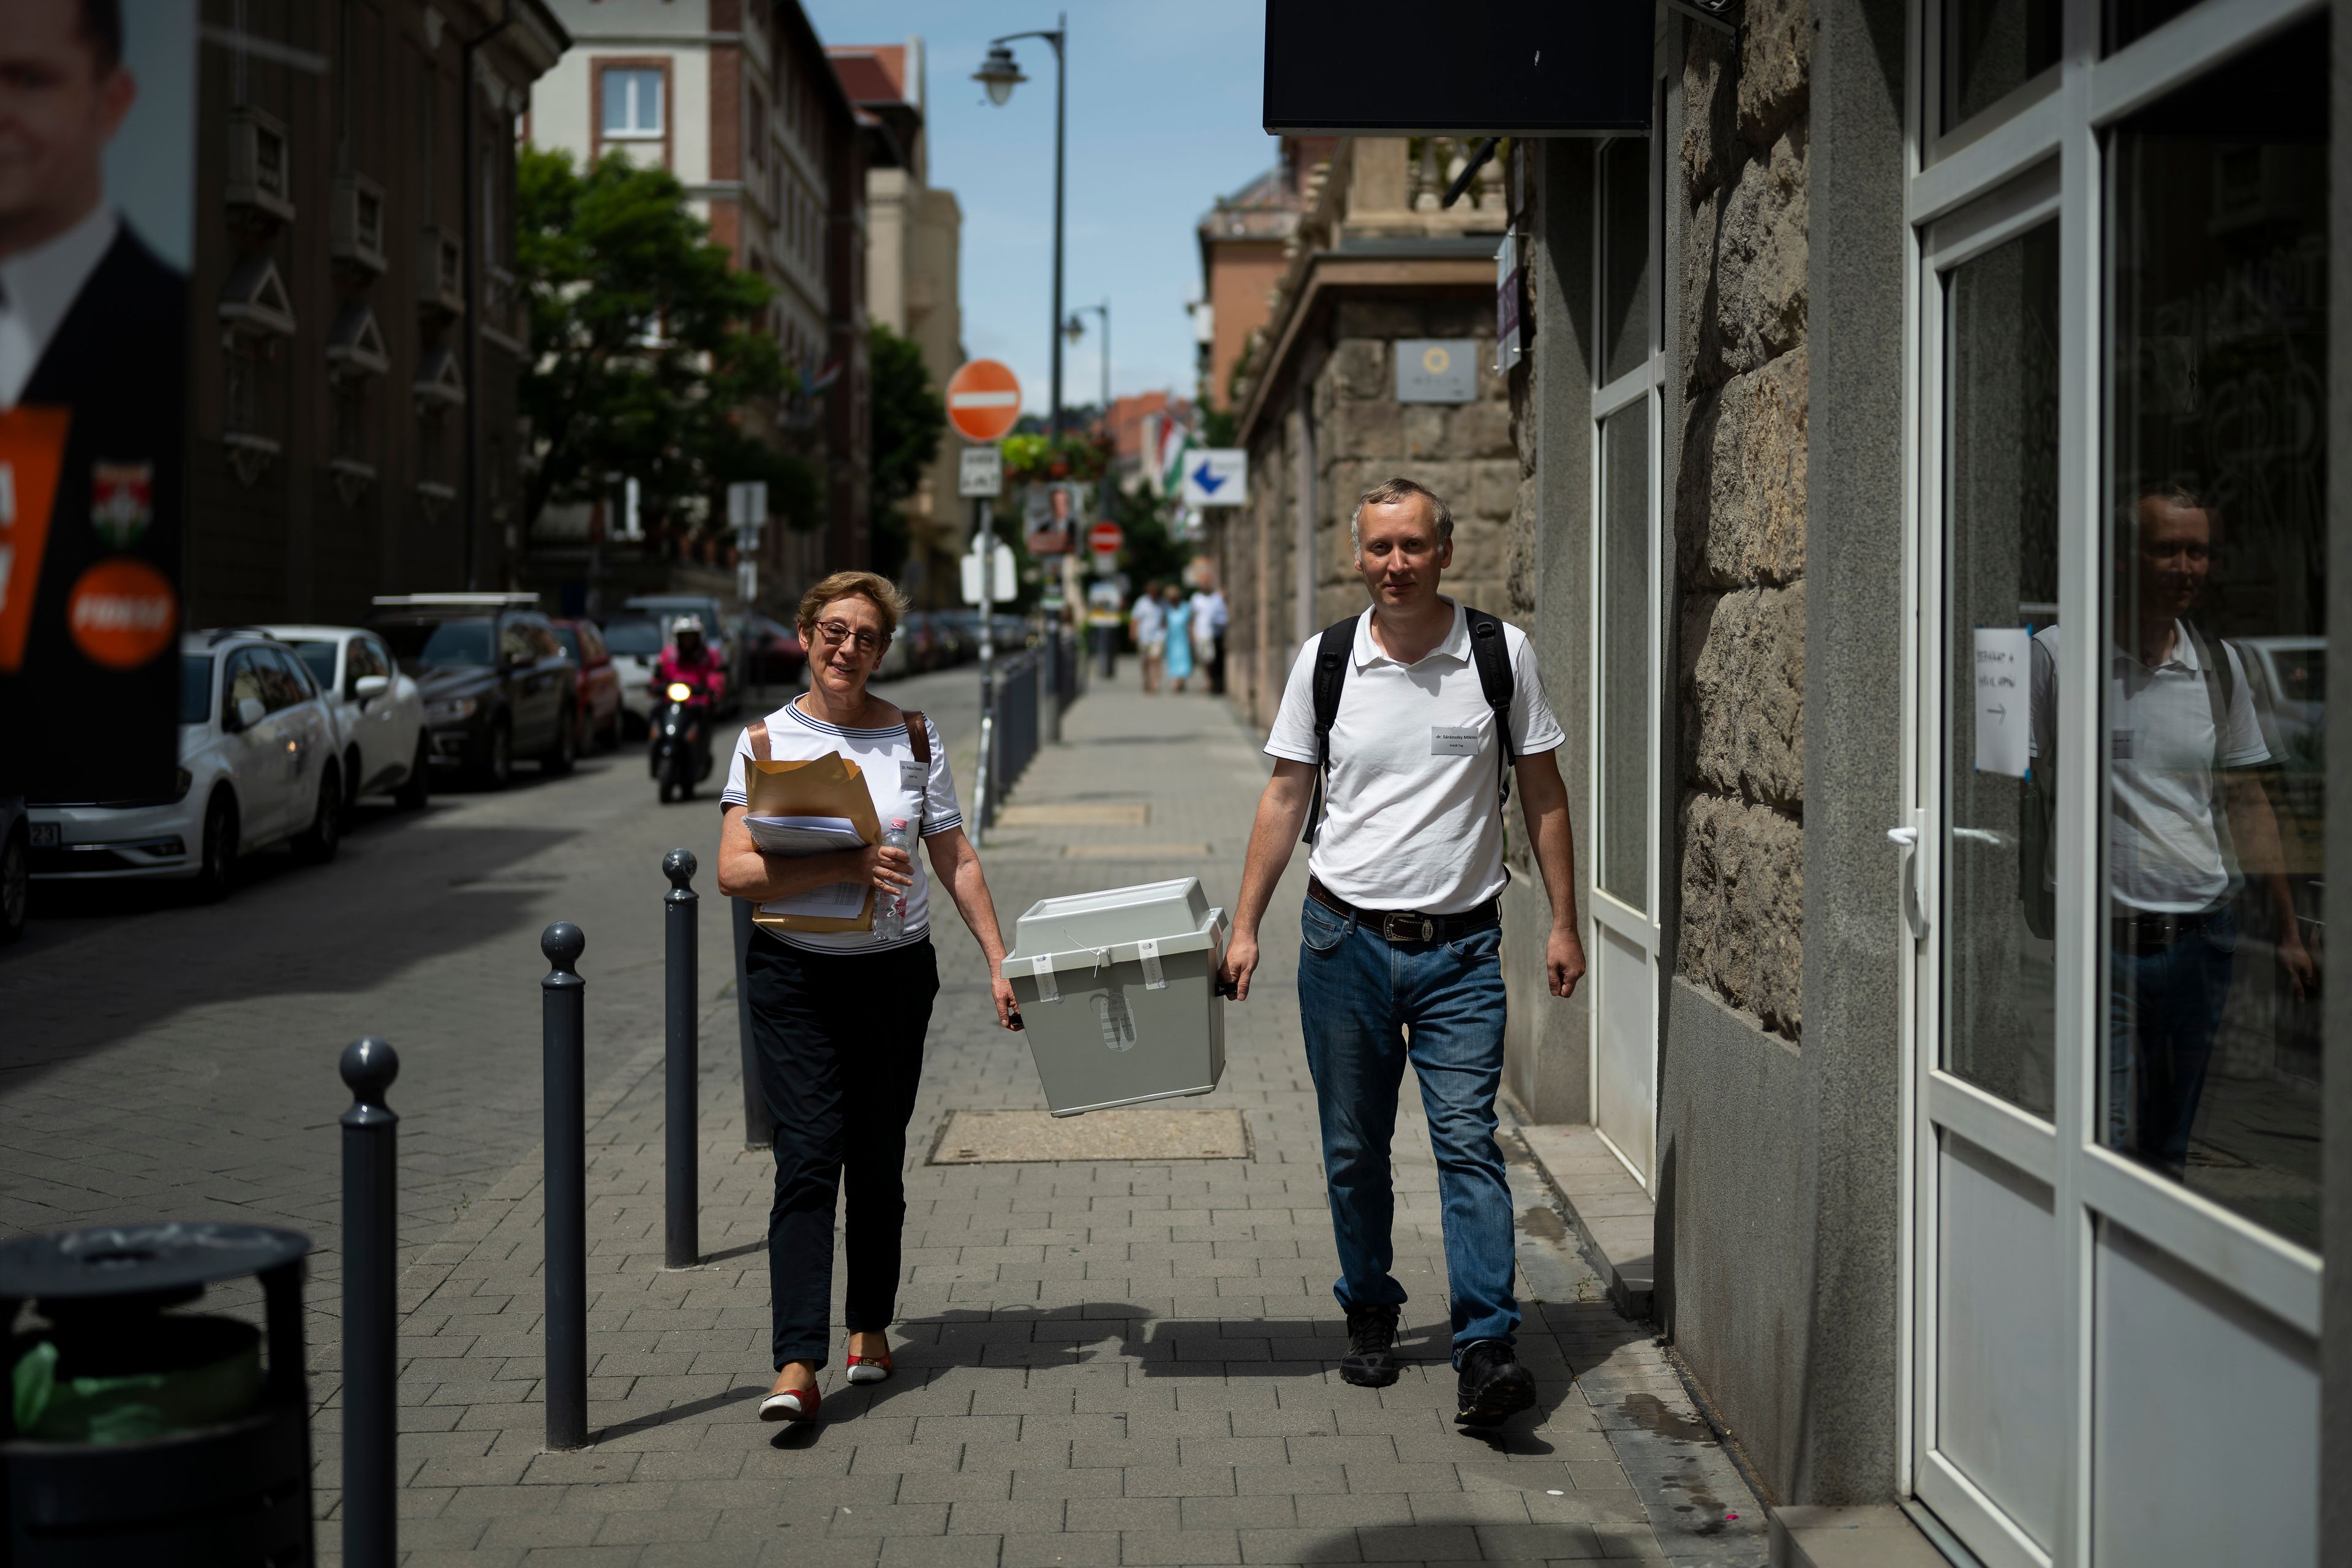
[[2032, 484, 2319, 1178]]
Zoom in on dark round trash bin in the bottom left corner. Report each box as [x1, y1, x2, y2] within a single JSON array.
[[0, 1225, 313, 1568]]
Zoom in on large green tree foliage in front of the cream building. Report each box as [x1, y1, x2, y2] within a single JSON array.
[[515, 148, 818, 540]]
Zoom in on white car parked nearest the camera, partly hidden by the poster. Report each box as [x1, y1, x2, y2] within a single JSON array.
[[33, 628, 344, 898]]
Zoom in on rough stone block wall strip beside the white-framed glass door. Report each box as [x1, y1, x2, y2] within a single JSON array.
[[1668, 12, 1814, 1039]]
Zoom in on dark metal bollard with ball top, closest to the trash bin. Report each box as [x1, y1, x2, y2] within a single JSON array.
[[339, 1039, 400, 1568]]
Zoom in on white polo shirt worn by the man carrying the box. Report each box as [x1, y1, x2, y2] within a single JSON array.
[[1265, 600, 1566, 914]]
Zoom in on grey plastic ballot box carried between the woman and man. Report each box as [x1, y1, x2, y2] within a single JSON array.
[[1005, 877, 1226, 1117]]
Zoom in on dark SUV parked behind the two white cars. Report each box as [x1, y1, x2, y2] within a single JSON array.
[[369, 592, 579, 790]]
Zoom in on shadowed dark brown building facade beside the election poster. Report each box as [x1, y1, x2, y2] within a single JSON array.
[[186, 0, 567, 625]]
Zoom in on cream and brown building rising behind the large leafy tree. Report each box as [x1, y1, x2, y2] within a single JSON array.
[[524, 0, 868, 604]]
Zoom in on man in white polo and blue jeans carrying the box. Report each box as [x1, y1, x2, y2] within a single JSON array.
[[1223, 480, 1585, 1427]]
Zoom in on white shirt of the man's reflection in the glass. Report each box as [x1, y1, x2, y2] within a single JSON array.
[[2032, 620, 2270, 914]]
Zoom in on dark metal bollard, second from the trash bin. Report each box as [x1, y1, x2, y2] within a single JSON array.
[[538, 919, 588, 1450]]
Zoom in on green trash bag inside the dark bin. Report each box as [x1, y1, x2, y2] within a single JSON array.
[[9, 1316, 261, 1444]]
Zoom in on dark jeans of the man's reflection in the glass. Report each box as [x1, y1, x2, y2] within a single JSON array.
[[2108, 907, 2237, 1170]]
